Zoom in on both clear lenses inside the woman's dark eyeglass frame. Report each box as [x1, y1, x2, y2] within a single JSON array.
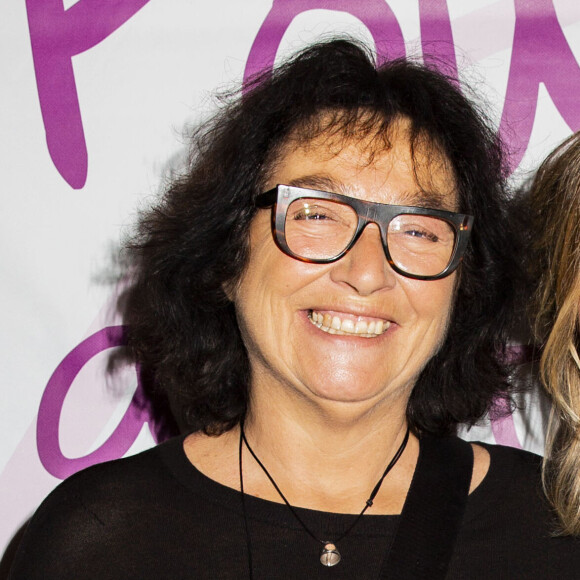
[[285, 198, 455, 276]]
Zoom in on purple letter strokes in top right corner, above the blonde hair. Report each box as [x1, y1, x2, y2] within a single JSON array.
[[500, 0, 580, 169]]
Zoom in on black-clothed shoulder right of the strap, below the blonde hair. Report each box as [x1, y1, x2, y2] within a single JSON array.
[[451, 443, 580, 579]]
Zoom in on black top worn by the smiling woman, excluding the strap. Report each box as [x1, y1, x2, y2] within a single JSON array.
[[10, 437, 580, 580]]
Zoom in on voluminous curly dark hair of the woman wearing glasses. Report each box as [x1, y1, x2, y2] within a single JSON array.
[[124, 39, 518, 435]]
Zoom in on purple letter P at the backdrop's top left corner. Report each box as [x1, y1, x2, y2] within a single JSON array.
[[26, 0, 149, 189]]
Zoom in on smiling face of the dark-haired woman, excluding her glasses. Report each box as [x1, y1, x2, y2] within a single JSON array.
[[231, 124, 457, 413]]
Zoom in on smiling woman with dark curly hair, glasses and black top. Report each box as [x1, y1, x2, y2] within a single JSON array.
[[13, 40, 580, 580]]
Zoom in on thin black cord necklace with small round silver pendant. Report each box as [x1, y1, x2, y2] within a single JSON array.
[[238, 419, 409, 576]]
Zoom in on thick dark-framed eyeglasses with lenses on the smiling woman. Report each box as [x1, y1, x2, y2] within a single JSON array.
[[256, 185, 473, 280]]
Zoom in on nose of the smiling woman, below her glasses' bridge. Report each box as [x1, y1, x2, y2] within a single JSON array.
[[331, 224, 396, 296]]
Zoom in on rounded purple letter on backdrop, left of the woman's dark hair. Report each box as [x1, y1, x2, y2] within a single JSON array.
[[36, 326, 156, 479]]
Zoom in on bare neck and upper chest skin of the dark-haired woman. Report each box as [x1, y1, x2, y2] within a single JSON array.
[[185, 378, 419, 514]]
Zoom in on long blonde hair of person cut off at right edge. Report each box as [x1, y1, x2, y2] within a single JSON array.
[[530, 132, 580, 535]]
